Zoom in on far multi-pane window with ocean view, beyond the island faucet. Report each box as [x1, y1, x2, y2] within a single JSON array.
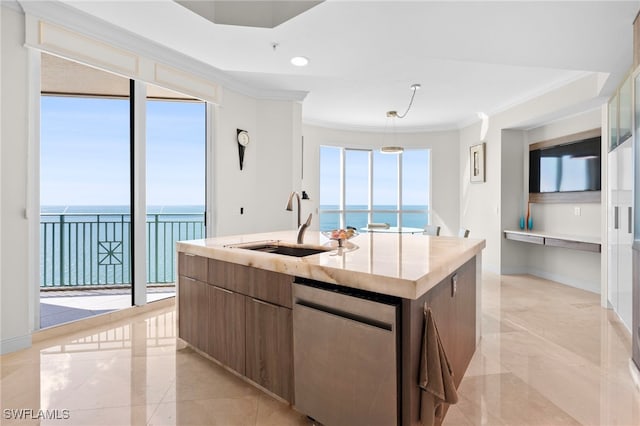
[[320, 146, 430, 231]]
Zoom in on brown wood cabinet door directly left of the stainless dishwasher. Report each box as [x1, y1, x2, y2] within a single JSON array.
[[246, 297, 293, 401]]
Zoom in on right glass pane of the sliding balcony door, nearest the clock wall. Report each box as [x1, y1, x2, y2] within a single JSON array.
[[146, 94, 206, 302]]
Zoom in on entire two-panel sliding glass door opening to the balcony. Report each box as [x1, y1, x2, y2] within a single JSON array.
[[40, 54, 207, 327]]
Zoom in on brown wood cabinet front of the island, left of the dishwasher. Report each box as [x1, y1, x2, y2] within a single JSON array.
[[178, 253, 293, 402]]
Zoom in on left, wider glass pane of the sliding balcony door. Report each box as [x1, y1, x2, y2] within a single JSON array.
[[40, 85, 132, 327]]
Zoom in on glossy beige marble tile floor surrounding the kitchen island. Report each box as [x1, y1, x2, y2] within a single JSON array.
[[0, 273, 640, 426]]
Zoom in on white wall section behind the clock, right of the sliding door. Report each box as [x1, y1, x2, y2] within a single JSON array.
[[213, 90, 301, 236]]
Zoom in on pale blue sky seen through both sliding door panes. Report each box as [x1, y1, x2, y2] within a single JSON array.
[[40, 96, 205, 210]]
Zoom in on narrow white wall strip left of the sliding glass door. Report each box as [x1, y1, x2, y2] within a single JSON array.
[[0, 6, 31, 353]]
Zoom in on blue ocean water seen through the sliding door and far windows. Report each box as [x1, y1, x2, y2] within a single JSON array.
[[40, 205, 428, 287]]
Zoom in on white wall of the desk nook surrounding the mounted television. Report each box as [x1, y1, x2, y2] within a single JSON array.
[[501, 108, 606, 293]]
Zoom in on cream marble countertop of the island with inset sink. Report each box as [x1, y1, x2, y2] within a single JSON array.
[[176, 231, 485, 299]]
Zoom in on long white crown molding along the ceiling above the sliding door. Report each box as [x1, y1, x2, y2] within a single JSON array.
[[17, 0, 307, 102]]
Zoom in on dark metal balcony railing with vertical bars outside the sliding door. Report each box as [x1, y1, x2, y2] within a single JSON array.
[[40, 213, 205, 288]]
